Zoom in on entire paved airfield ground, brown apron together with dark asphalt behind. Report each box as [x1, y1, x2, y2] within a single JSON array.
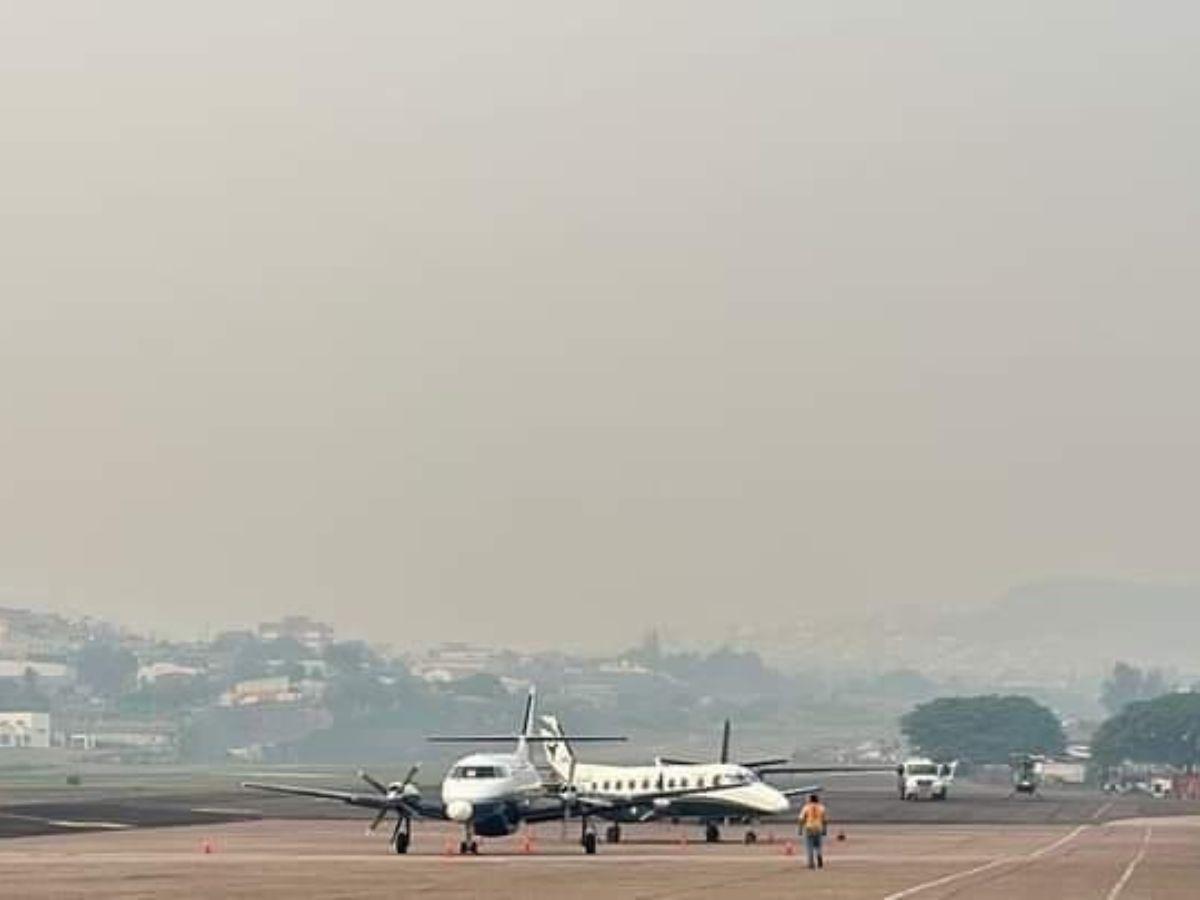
[[0, 780, 1200, 900]]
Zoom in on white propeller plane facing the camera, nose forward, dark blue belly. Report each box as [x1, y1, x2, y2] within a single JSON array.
[[241, 689, 715, 854]]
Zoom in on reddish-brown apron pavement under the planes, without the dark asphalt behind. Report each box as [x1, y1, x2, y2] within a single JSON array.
[[0, 817, 1200, 900]]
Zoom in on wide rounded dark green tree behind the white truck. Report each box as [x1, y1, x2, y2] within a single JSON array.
[[900, 695, 1067, 763]]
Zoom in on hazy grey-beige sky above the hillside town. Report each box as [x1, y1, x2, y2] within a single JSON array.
[[0, 0, 1200, 647]]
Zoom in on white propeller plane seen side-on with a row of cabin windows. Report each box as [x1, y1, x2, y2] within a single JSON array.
[[540, 715, 892, 844]]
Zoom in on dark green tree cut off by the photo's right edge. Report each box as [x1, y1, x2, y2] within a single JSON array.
[[1092, 692, 1200, 767]]
